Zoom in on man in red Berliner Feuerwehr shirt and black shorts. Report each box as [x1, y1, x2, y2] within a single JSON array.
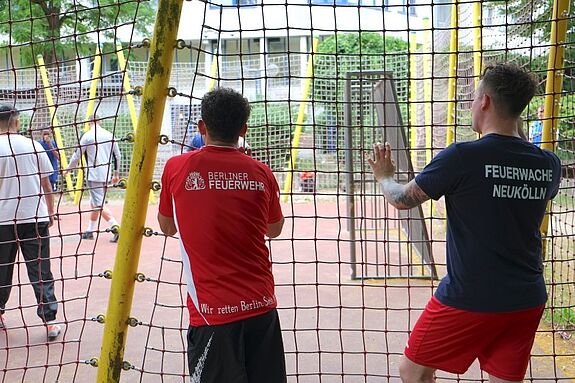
[[158, 88, 287, 383]]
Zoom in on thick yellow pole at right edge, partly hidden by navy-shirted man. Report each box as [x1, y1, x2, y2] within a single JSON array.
[[541, 0, 569, 257]]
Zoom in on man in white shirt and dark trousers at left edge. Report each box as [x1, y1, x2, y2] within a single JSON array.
[[0, 105, 61, 340]]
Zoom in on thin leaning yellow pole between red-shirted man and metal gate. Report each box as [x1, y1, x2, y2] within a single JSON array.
[[282, 38, 319, 202]]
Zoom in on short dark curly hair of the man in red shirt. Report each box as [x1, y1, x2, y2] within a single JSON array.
[[201, 88, 250, 143]]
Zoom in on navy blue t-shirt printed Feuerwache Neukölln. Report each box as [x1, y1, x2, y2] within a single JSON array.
[[415, 134, 561, 312]]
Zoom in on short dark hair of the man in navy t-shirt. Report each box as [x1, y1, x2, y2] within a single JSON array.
[[481, 63, 537, 118]]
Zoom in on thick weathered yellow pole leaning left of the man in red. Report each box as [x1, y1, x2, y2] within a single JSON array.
[[97, 0, 184, 383]]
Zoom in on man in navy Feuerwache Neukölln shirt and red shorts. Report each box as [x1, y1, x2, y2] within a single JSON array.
[[369, 64, 561, 382]]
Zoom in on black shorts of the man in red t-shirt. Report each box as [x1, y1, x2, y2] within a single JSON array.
[[188, 309, 287, 383]]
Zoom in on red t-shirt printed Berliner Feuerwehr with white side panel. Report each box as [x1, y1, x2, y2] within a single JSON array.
[[159, 146, 283, 326]]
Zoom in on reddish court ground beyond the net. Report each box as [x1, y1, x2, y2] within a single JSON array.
[[0, 200, 574, 383]]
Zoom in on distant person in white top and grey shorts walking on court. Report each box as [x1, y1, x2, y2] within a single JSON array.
[[63, 115, 122, 242]]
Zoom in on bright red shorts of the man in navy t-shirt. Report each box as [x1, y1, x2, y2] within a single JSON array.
[[405, 297, 545, 381]]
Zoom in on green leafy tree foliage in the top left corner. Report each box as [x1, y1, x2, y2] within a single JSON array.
[[0, 0, 154, 65]]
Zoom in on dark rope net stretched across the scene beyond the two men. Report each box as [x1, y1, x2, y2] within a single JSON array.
[[0, 0, 575, 382]]
